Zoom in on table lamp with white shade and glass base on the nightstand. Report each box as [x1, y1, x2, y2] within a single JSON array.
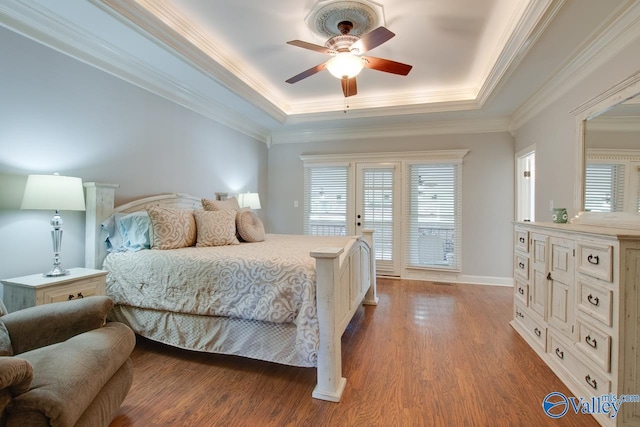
[[20, 174, 85, 277]]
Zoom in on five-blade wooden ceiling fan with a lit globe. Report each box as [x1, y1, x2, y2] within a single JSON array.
[[287, 21, 412, 97]]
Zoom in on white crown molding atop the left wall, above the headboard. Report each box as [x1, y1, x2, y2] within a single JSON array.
[[0, 0, 270, 144]]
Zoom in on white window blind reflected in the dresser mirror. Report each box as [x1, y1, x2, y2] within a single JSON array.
[[584, 163, 625, 212]]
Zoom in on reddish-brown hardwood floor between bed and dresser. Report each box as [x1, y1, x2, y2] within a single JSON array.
[[111, 279, 598, 427]]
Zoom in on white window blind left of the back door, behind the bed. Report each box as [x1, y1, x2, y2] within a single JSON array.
[[304, 166, 350, 236]]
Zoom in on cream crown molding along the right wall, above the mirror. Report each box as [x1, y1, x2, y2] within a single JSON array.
[[511, 1, 640, 132]]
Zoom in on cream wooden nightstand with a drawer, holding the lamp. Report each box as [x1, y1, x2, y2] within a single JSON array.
[[2, 268, 107, 312]]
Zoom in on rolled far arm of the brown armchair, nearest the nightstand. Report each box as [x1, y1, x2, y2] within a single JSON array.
[[2, 296, 113, 354]]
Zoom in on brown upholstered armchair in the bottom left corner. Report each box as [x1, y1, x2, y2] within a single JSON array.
[[0, 296, 135, 426]]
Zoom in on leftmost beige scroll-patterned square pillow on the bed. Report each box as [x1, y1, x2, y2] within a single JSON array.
[[147, 206, 196, 249]]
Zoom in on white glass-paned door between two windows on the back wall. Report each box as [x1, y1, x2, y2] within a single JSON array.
[[355, 163, 401, 276]]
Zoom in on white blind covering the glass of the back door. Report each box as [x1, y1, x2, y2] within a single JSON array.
[[362, 168, 394, 261]]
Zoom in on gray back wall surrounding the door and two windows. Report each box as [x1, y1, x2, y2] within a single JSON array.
[[266, 132, 515, 278]]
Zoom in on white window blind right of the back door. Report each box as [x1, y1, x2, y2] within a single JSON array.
[[405, 163, 462, 270]]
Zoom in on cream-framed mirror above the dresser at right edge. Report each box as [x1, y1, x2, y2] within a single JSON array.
[[572, 71, 640, 228]]
